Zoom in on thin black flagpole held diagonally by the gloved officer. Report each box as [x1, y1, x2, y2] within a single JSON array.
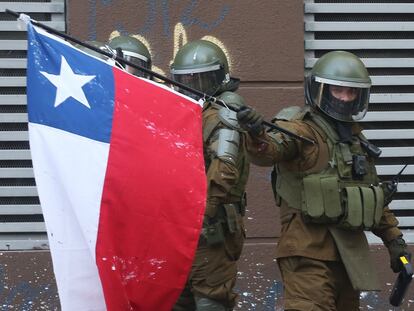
[[5, 9, 315, 145]]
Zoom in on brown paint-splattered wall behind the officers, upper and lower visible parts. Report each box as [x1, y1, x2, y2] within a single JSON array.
[[0, 0, 414, 311]]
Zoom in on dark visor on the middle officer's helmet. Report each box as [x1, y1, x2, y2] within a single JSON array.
[[172, 69, 225, 98]]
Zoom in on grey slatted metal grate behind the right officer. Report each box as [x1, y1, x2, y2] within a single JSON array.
[[304, 0, 414, 242]]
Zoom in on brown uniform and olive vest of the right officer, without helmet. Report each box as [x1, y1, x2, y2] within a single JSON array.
[[243, 107, 401, 311]]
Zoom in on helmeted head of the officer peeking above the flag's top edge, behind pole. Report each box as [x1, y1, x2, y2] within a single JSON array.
[[108, 35, 151, 78]]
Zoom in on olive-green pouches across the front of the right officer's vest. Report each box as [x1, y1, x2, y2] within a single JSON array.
[[301, 175, 384, 230]]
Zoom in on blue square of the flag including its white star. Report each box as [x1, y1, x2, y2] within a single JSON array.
[[27, 27, 114, 142]]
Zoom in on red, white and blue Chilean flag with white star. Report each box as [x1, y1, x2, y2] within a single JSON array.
[[27, 23, 206, 311]]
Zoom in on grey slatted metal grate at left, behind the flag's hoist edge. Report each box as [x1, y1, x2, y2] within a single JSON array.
[[0, 0, 66, 250]]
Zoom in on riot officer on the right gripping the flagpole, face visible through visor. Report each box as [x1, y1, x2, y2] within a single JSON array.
[[237, 51, 411, 311]]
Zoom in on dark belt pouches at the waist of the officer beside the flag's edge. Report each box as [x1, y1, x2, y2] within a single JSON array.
[[199, 196, 246, 246]]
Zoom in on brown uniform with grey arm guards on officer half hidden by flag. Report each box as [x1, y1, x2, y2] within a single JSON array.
[[173, 92, 249, 310]]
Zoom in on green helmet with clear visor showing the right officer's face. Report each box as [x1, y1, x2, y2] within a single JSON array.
[[305, 51, 371, 122]]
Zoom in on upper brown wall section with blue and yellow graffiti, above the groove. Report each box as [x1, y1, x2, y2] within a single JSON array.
[[68, 0, 303, 82]]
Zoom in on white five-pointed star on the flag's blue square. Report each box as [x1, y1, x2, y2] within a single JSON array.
[[40, 55, 96, 109]]
